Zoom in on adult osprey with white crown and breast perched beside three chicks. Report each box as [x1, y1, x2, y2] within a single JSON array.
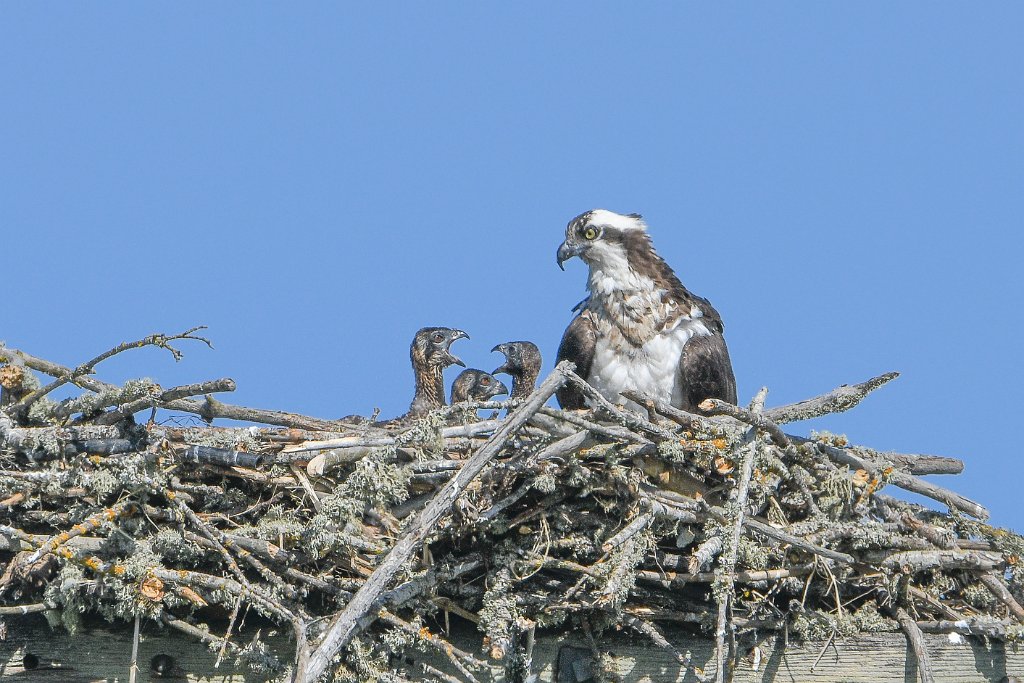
[[558, 209, 736, 411]]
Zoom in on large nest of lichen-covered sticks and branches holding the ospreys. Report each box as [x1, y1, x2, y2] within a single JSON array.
[[0, 330, 1024, 681]]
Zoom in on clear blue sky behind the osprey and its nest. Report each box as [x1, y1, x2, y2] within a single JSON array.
[[0, 2, 1024, 530]]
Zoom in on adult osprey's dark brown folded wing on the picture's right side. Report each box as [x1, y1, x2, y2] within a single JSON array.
[[677, 299, 736, 413]]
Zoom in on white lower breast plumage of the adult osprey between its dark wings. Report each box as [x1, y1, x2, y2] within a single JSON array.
[[587, 317, 711, 411]]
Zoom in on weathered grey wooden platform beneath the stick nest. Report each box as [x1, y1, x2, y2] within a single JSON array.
[[0, 617, 1024, 683]]
